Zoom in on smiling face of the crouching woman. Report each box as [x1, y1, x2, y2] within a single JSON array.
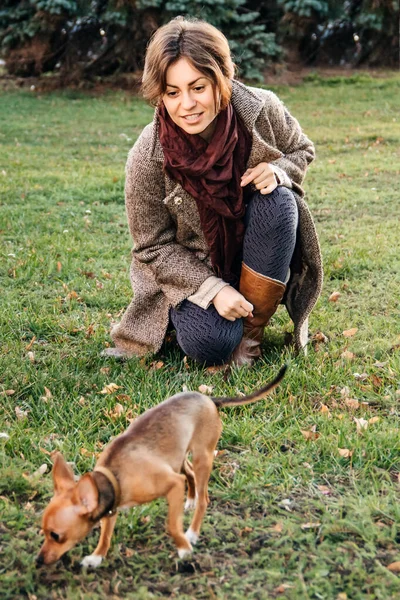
[[163, 58, 217, 141]]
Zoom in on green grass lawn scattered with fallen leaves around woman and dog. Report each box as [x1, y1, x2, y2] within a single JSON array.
[[0, 75, 400, 600]]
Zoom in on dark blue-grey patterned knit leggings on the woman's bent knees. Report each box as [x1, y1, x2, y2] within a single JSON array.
[[170, 186, 298, 365]]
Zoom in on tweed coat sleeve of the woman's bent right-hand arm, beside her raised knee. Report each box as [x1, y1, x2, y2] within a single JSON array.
[[256, 91, 315, 195]]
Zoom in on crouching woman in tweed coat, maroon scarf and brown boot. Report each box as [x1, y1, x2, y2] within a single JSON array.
[[107, 17, 322, 365]]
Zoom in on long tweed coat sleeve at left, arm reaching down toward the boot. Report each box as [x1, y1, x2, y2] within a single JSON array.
[[125, 130, 213, 306]]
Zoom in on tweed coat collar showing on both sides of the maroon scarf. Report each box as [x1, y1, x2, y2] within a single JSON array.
[[150, 79, 265, 161]]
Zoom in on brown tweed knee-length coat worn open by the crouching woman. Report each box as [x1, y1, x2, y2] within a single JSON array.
[[111, 81, 323, 356]]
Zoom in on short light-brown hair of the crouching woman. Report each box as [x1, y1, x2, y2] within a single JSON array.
[[142, 17, 235, 110]]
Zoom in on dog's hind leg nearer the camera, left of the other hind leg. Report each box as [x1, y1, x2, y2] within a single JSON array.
[[166, 473, 192, 558]]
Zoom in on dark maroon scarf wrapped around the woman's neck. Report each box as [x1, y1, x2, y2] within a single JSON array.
[[159, 104, 252, 284]]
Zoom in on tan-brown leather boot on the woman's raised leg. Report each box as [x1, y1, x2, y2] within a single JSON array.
[[231, 263, 286, 366]]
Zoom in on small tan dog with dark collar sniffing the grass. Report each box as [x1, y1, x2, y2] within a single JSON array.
[[37, 366, 286, 567]]
